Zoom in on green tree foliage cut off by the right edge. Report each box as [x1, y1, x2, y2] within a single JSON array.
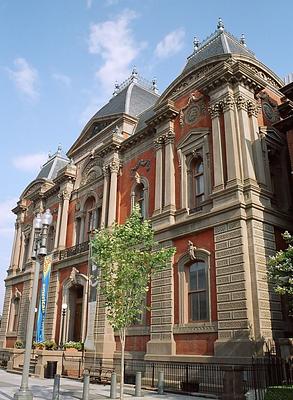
[[268, 231, 293, 313]]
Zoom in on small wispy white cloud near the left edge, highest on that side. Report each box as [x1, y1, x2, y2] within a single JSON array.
[[7, 58, 39, 100]]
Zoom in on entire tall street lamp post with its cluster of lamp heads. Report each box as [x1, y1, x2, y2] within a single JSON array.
[[14, 209, 52, 400]]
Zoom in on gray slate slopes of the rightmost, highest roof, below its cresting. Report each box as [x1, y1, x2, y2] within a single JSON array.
[[183, 29, 255, 72]]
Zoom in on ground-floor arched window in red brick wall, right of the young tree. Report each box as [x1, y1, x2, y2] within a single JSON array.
[[187, 260, 209, 322]]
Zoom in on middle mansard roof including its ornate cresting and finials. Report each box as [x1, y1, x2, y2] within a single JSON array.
[[93, 69, 159, 118]]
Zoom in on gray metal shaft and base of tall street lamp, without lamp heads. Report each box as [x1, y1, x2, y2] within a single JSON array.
[[14, 257, 40, 400]]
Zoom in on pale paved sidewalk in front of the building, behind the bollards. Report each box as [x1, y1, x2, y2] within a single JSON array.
[[0, 370, 214, 400]]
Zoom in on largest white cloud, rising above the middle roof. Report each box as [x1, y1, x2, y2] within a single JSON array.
[[88, 10, 145, 94]]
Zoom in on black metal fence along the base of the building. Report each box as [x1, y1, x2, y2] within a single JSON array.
[[81, 357, 293, 400]]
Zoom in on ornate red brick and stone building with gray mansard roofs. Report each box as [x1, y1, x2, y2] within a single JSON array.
[[0, 21, 292, 368]]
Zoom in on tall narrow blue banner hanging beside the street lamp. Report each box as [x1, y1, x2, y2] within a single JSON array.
[[36, 254, 52, 343]]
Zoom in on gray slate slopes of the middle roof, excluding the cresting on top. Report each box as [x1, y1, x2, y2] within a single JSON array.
[[94, 82, 159, 118]]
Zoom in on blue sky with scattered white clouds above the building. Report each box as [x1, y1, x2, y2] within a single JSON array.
[[0, 0, 293, 310]]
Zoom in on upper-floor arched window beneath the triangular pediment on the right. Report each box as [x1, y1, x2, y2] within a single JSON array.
[[190, 158, 205, 209]]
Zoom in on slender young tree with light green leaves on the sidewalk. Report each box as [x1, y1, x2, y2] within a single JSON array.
[[91, 206, 175, 399]]
